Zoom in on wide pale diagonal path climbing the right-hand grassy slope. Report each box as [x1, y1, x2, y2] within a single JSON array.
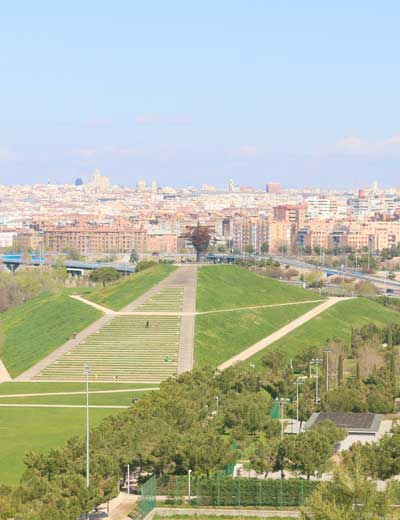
[[218, 298, 351, 370]]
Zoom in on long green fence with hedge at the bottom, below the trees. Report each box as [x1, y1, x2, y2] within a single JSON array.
[[157, 475, 316, 507]]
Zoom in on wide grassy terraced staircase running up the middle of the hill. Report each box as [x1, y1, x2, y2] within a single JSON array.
[[34, 286, 184, 383]]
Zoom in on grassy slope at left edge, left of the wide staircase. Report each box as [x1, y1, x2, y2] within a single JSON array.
[[0, 293, 102, 377]]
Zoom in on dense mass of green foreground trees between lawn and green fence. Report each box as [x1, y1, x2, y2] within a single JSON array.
[[0, 365, 342, 520]]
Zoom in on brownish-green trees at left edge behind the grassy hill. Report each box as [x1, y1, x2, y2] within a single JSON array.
[[0, 266, 68, 312]]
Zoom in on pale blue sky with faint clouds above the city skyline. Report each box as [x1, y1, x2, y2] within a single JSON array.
[[0, 0, 400, 187]]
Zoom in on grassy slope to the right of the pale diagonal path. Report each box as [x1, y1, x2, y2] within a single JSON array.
[[249, 298, 400, 364]]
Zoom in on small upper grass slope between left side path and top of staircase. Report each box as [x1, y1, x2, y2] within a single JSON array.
[[86, 264, 176, 311]]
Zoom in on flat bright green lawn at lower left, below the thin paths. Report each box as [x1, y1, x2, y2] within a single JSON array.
[[0, 408, 121, 484]]
